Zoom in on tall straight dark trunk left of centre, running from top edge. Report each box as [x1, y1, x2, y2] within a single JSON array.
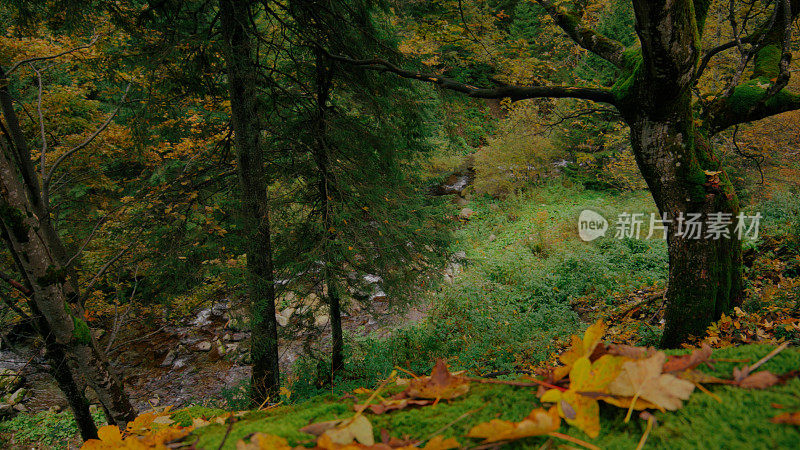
[[219, 0, 280, 404]]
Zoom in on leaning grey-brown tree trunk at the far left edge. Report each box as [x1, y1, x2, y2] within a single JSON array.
[[0, 69, 136, 439]]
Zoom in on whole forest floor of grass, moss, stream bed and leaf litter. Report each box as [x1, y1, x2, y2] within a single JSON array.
[[0, 184, 800, 448]]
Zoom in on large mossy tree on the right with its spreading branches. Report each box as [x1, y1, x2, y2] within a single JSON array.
[[328, 0, 800, 347]]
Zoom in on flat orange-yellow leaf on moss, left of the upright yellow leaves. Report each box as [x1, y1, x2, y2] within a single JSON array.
[[467, 407, 561, 443]]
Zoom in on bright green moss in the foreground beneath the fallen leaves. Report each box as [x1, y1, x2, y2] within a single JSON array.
[[182, 345, 800, 449]]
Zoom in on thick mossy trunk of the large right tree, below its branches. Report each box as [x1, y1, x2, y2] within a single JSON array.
[[630, 109, 742, 348]]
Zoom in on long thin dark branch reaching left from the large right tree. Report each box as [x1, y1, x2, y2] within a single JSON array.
[[322, 49, 616, 105]]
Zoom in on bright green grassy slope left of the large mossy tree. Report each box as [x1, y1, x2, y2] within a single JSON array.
[[291, 183, 667, 399]]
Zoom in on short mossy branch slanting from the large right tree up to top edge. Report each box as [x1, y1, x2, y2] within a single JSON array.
[[536, 0, 627, 69]]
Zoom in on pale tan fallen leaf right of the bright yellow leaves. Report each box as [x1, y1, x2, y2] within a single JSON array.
[[608, 352, 694, 411]]
